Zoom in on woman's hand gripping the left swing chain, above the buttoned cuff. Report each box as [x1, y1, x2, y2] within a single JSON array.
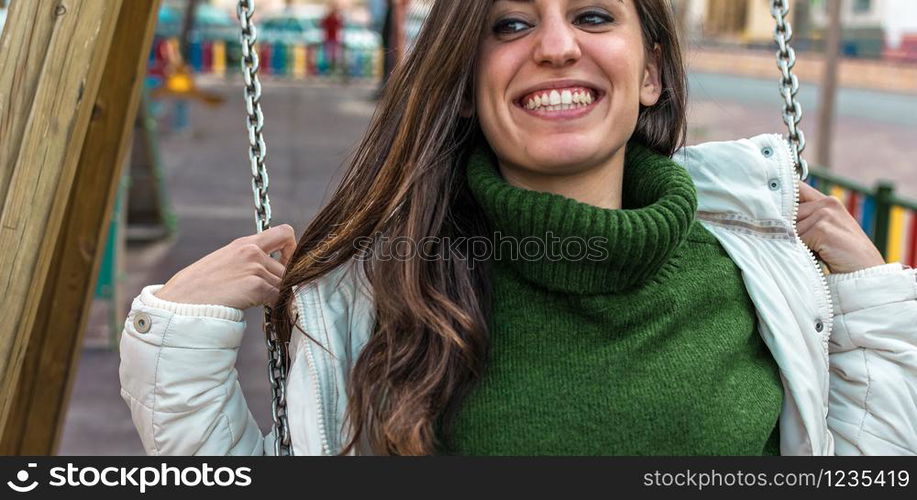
[[155, 225, 296, 310]]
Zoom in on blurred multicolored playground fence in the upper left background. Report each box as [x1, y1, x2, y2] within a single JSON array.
[[150, 38, 382, 80]]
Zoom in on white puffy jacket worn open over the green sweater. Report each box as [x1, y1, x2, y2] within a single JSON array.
[[120, 135, 917, 455]]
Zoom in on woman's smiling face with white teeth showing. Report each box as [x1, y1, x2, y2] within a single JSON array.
[[475, 0, 661, 174]]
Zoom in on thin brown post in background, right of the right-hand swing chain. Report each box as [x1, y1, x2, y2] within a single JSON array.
[[815, 0, 842, 168]]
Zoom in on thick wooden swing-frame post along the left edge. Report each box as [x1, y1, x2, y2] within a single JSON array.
[[0, 0, 159, 455]]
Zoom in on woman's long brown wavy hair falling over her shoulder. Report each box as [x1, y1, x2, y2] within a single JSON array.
[[273, 0, 685, 455]]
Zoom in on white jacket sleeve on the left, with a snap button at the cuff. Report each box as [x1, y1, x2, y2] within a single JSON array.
[[119, 286, 273, 455]]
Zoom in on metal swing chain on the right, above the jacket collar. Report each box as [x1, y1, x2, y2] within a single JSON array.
[[771, 0, 809, 180]]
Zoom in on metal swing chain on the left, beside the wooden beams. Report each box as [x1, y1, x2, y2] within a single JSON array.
[[236, 0, 293, 456]]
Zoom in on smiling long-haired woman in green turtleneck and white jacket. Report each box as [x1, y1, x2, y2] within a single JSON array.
[[121, 0, 917, 455]]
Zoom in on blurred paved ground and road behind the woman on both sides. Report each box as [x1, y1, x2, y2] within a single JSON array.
[[59, 75, 917, 455]]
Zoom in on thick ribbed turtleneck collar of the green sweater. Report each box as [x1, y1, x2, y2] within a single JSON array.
[[467, 143, 697, 295]]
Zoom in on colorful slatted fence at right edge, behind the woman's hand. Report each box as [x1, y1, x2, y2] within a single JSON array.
[[806, 168, 917, 267]]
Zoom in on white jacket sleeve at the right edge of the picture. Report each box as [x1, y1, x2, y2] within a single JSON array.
[[828, 263, 917, 455]]
